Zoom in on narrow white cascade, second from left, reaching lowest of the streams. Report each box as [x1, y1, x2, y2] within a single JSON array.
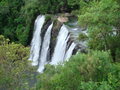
[[37, 23, 53, 73]]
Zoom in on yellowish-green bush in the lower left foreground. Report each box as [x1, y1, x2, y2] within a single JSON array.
[[0, 36, 35, 90]]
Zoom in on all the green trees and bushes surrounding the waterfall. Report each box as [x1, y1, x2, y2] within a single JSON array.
[[0, 0, 120, 90]]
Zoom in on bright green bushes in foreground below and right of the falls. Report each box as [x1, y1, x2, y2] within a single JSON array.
[[37, 51, 120, 90]]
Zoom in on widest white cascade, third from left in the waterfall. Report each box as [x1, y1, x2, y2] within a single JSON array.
[[50, 25, 69, 65]]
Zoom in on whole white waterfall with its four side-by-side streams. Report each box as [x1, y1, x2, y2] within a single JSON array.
[[29, 15, 79, 73]]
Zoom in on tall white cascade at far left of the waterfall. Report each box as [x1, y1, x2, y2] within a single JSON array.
[[29, 15, 45, 66]]
